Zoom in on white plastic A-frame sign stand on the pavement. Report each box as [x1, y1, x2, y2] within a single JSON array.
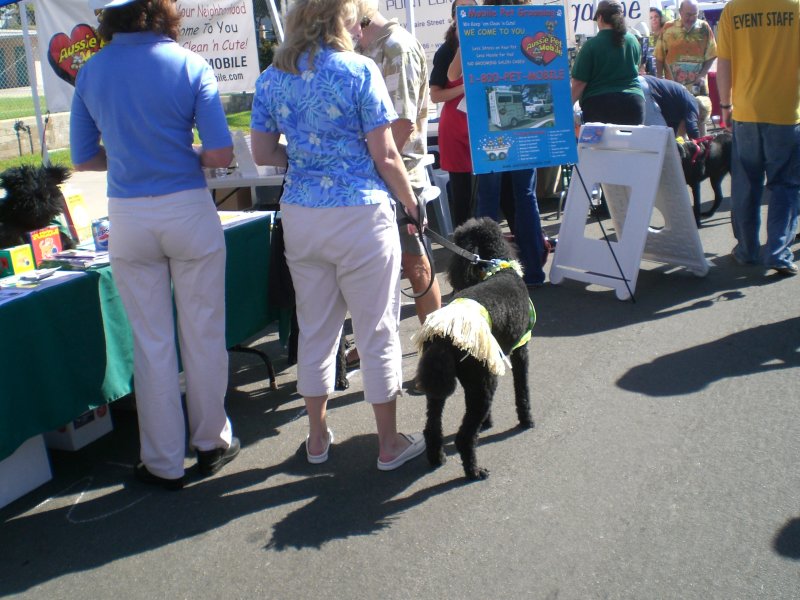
[[550, 123, 709, 300]]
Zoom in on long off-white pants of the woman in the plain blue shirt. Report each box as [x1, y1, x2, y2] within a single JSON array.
[[109, 188, 232, 479]]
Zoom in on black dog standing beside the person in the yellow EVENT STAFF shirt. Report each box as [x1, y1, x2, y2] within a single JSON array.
[[678, 131, 733, 227]]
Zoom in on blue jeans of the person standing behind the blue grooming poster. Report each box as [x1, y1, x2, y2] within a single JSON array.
[[475, 169, 545, 285]]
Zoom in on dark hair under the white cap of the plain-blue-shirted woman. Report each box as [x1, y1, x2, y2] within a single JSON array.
[[97, 0, 181, 42]]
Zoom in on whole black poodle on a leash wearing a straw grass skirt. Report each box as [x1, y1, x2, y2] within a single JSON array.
[[416, 217, 536, 480]]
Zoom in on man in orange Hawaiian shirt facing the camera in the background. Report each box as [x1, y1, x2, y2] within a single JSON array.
[[655, 0, 717, 136]]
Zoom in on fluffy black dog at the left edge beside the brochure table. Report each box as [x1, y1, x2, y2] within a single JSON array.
[[0, 165, 75, 248]]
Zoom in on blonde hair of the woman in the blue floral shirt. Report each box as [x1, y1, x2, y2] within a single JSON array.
[[272, 0, 360, 74]]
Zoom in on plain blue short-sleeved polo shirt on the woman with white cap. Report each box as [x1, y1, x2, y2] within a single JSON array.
[[70, 32, 233, 198]]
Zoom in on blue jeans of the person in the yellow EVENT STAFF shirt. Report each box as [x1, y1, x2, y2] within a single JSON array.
[[731, 121, 800, 267]]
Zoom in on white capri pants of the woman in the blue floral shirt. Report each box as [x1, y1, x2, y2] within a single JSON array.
[[281, 202, 402, 404]]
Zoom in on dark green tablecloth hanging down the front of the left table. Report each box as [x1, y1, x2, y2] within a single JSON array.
[[0, 213, 279, 474]]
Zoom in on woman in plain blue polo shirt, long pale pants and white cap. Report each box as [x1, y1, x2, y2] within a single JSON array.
[[70, 0, 239, 490]]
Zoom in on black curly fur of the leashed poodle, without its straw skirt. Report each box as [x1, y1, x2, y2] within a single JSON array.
[[417, 218, 534, 479]]
